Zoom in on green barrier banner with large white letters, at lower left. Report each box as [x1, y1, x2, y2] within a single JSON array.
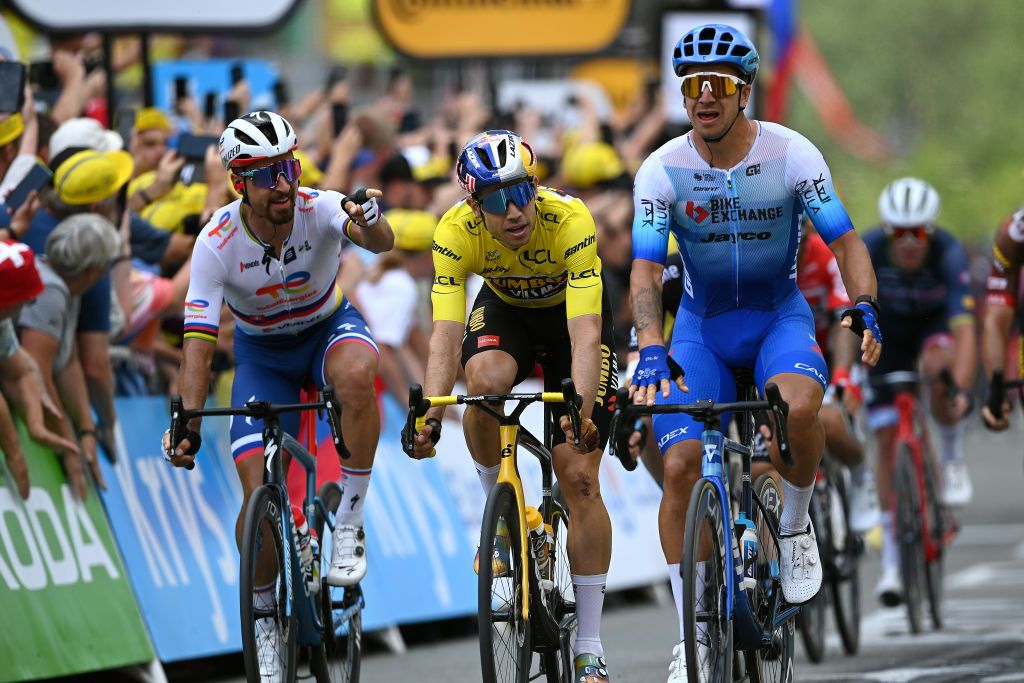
[[0, 424, 154, 682]]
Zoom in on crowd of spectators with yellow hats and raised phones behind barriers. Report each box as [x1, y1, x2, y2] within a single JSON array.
[[0, 33, 667, 498]]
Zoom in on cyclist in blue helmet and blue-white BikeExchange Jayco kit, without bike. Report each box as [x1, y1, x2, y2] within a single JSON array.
[[630, 24, 882, 681]]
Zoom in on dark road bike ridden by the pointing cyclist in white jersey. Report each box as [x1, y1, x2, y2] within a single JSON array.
[[171, 387, 365, 683]]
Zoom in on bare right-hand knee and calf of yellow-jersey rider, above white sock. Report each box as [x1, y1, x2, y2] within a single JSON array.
[[551, 443, 611, 574]]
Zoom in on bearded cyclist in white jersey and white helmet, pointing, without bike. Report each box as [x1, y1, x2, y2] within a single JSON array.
[[164, 112, 394, 643]]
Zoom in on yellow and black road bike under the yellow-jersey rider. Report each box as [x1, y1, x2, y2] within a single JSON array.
[[406, 379, 581, 683]]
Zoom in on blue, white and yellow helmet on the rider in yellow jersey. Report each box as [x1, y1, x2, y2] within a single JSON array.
[[455, 130, 537, 195]]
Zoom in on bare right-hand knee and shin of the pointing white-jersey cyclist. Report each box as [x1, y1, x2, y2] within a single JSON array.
[[325, 341, 381, 469]]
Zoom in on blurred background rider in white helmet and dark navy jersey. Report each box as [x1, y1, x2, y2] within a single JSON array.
[[864, 177, 977, 605]]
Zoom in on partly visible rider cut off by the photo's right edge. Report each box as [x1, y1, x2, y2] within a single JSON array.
[[981, 202, 1024, 431]]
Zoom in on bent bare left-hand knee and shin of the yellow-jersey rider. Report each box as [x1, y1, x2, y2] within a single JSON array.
[[462, 349, 516, 471]]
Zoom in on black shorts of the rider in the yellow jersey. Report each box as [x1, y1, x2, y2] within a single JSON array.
[[462, 285, 618, 449]]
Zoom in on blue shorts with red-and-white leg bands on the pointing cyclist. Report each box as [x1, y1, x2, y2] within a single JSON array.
[[231, 298, 379, 462]]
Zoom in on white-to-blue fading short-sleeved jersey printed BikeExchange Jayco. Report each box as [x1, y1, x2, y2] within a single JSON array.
[[633, 122, 853, 316]]
